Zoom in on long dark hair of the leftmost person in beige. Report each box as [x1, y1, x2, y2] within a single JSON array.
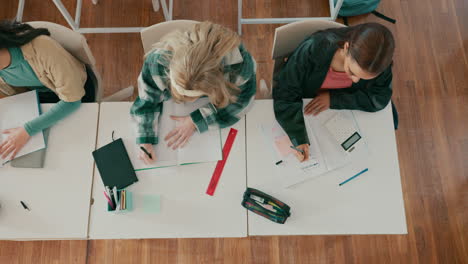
[[0, 20, 50, 49]]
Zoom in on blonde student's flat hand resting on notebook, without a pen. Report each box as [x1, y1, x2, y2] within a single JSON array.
[[164, 116, 196, 149]]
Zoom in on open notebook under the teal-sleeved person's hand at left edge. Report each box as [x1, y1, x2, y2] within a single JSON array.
[[0, 91, 46, 167]]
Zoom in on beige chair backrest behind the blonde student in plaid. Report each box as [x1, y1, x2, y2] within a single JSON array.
[[140, 20, 199, 54]]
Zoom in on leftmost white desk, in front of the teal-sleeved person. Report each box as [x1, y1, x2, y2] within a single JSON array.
[[0, 103, 98, 240]]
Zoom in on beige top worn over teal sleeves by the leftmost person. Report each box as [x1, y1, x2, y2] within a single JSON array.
[[0, 36, 87, 102]]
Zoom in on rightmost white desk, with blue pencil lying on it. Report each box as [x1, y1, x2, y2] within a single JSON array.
[[247, 100, 407, 235]]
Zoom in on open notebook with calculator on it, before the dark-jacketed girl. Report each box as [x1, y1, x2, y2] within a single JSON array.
[[262, 100, 368, 187]]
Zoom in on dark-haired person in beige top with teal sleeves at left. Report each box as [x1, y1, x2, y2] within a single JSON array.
[[0, 21, 95, 159]]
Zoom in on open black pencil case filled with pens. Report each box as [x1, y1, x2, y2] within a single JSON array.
[[242, 188, 291, 224]]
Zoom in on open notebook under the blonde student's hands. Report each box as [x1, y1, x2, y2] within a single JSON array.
[[126, 98, 222, 170]]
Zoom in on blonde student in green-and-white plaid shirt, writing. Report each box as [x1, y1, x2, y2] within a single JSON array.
[[130, 22, 256, 164]]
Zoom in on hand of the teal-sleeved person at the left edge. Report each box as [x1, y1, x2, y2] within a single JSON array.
[[0, 127, 30, 160]]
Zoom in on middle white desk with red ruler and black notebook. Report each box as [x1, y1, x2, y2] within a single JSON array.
[[89, 102, 247, 239]]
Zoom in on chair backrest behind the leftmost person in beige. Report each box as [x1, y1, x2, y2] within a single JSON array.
[[27, 21, 102, 101]]
